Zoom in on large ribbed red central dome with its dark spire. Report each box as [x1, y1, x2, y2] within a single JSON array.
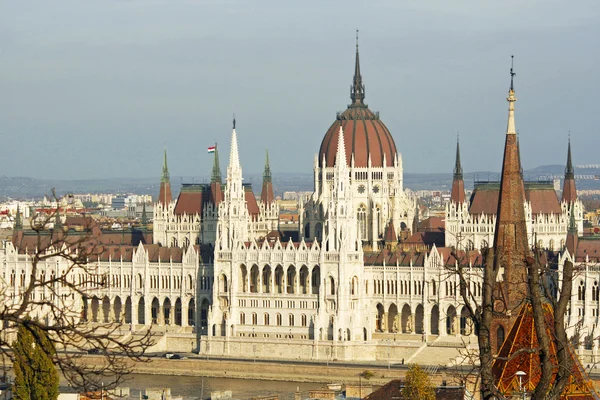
[[319, 44, 396, 168]]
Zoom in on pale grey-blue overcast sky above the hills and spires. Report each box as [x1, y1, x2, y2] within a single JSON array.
[[0, 0, 600, 179]]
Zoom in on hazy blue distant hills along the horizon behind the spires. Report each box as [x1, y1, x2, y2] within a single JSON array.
[[0, 165, 600, 199]]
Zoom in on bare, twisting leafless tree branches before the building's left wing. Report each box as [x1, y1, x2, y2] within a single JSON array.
[[0, 191, 152, 391]]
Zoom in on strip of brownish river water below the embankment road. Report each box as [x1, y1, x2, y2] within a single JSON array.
[[117, 376, 324, 400]]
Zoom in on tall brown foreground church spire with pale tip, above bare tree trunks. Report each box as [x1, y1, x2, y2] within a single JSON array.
[[493, 54, 530, 345]]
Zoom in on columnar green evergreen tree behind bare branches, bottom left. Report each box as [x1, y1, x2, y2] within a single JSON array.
[[13, 324, 59, 400]]
